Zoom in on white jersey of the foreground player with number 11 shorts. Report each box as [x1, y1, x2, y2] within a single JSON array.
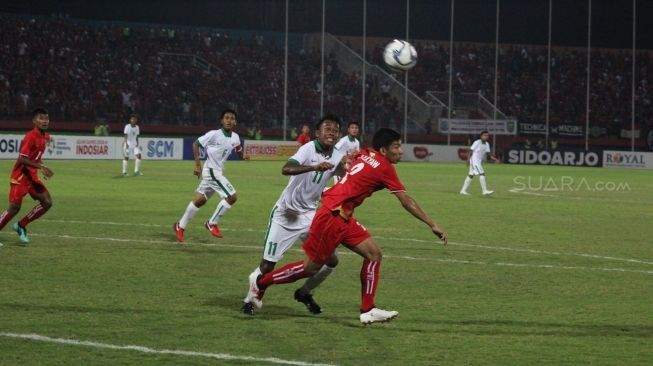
[[276, 140, 344, 213]]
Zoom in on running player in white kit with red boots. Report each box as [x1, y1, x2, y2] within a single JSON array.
[[173, 109, 248, 243]]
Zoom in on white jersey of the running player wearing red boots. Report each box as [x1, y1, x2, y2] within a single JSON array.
[[197, 128, 242, 176]]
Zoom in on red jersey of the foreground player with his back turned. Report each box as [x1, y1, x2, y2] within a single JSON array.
[[322, 149, 406, 217]]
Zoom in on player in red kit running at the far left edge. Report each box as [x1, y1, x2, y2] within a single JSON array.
[[0, 108, 54, 243]]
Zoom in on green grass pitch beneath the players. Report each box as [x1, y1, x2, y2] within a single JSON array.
[[0, 161, 653, 365]]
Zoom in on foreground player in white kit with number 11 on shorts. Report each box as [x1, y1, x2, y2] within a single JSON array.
[[242, 115, 346, 315]]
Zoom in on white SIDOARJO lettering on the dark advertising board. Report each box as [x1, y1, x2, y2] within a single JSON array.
[[508, 150, 601, 166]]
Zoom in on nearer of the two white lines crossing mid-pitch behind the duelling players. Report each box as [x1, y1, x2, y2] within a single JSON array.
[[12, 234, 653, 275]]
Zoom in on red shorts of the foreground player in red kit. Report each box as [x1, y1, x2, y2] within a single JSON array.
[[303, 207, 370, 264]]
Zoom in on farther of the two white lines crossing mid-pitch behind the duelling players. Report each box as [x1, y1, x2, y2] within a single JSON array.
[[41, 219, 653, 265]]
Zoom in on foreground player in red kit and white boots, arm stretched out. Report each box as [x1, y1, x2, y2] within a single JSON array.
[[248, 128, 448, 324]]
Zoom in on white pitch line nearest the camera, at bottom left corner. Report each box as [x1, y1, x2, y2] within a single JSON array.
[[0, 332, 331, 366]]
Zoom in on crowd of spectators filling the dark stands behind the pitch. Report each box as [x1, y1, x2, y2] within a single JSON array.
[[0, 15, 653, 136]]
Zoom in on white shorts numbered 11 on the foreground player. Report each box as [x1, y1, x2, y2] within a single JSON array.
[[263, 206, 315, 263]]
